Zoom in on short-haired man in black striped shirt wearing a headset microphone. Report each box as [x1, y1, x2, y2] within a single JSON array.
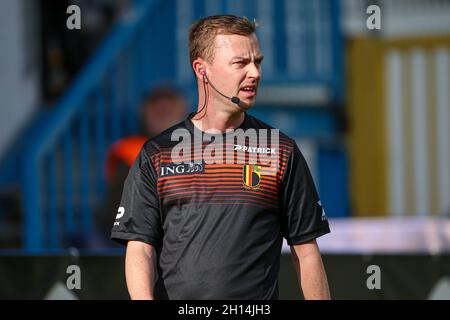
[[112, 16, 330, 299]]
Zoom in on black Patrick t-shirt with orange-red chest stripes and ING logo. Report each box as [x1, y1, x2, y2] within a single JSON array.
[[111, 114, 330, 299]]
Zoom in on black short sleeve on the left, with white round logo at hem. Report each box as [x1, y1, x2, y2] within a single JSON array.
[[111, 148, 163, 248]]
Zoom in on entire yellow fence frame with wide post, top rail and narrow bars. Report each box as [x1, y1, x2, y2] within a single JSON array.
[[346, 35, 450, 216]]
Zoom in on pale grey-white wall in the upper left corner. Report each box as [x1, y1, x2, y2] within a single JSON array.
[[0, 0, 40, 158]]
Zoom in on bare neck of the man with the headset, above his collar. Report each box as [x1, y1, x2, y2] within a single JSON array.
[[192, 107, 245, 133]]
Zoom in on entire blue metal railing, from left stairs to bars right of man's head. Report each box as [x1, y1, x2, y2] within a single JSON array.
[[21, 0, 343, 253]]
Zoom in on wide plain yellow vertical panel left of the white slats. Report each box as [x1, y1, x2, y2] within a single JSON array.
[[347, 39, 387, 216]]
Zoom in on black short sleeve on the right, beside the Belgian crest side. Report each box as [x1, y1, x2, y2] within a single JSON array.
[[281, 142, 330, 245]]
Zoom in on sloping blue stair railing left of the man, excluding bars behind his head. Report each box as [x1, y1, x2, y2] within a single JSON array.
[[21, 0, 162, 253]]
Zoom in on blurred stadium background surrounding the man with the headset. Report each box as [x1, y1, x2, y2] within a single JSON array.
[[0, 0, 450, 299]]
